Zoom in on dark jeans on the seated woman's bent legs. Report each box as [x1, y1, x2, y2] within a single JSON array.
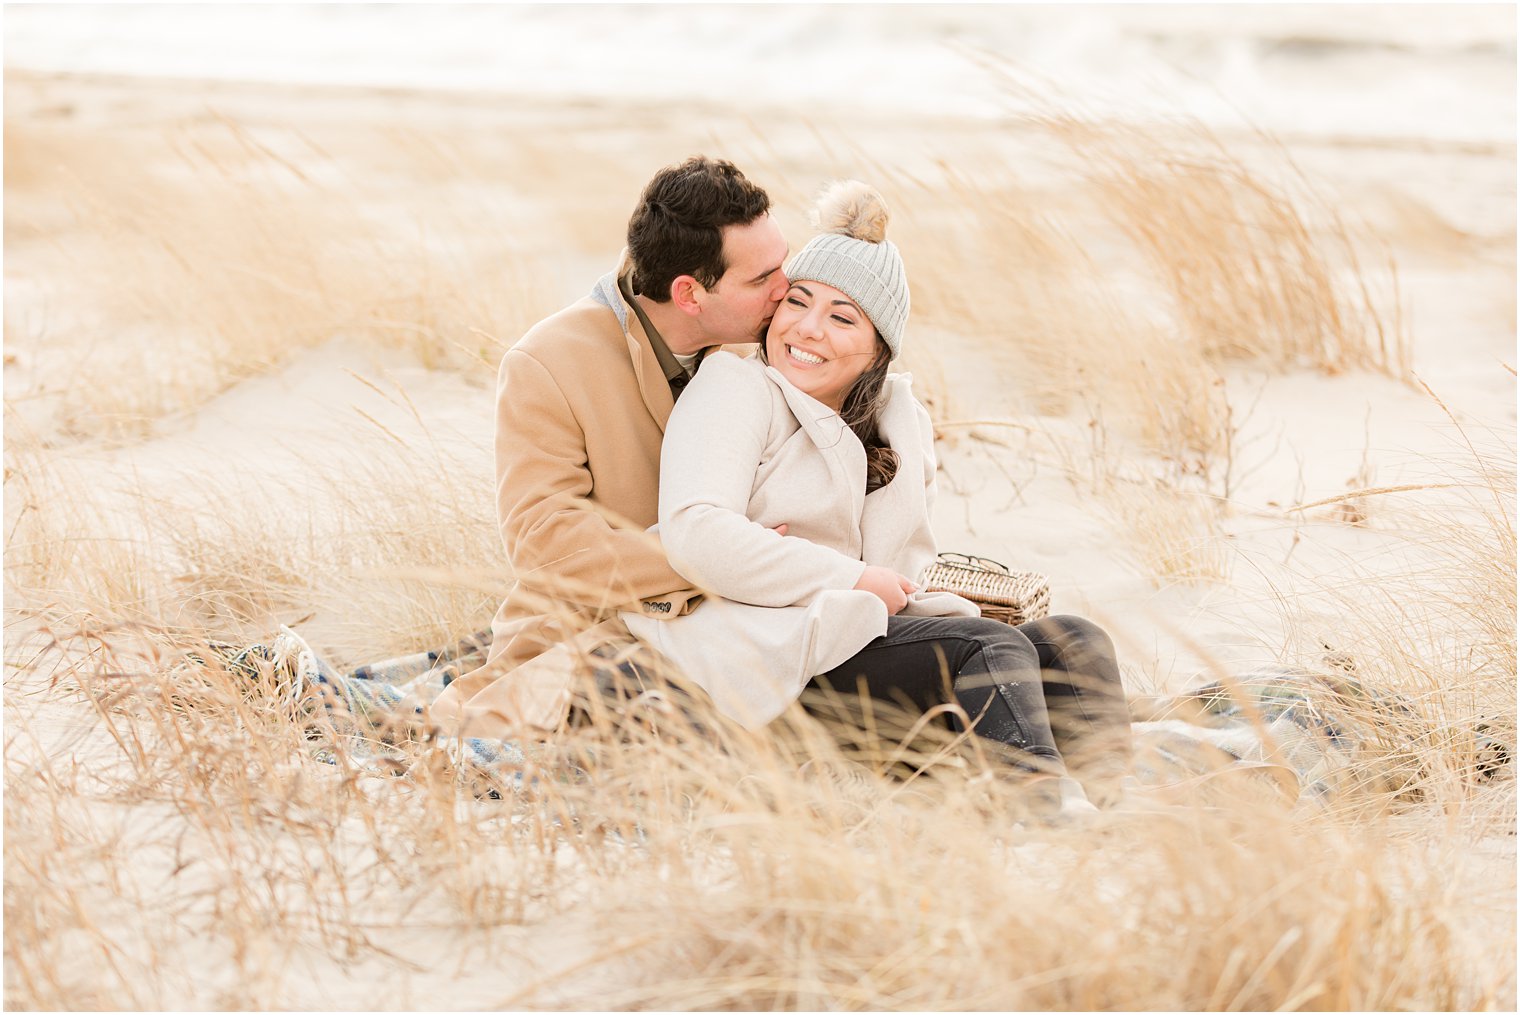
[[804, 617, 1131, 784]]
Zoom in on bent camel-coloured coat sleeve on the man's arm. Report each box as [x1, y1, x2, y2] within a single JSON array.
[[496, 349, 690, 608]]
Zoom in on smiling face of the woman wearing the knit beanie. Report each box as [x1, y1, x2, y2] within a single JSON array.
[[765, 280, 876, 412]]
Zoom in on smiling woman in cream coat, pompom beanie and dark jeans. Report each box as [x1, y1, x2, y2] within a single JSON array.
[[625, 181, 1128, 813]]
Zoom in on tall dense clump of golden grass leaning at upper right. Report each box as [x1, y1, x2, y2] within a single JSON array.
[[1050, 119, 1409, 378]]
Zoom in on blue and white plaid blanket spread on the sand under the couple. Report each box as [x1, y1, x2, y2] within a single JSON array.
[[213, 626, 1514, 804]]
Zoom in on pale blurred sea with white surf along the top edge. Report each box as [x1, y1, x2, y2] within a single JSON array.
[[5, 5, 1515, 141]]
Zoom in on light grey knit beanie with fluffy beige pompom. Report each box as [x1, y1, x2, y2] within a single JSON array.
[[786, 179, 907, 359]]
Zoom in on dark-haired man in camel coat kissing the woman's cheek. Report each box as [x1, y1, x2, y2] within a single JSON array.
[[432, 157, 787, 737]]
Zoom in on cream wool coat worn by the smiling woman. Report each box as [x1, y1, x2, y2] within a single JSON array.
[[623, 353, 977, 728]]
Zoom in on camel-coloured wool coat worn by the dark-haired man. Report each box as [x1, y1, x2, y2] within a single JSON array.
[[430, 251, 699, 735]]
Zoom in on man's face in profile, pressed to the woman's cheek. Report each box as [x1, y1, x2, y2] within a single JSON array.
[[701, 214, 786, 345]]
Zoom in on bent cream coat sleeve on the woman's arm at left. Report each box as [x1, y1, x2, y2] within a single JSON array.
[[660, 354, 865, 606]]
